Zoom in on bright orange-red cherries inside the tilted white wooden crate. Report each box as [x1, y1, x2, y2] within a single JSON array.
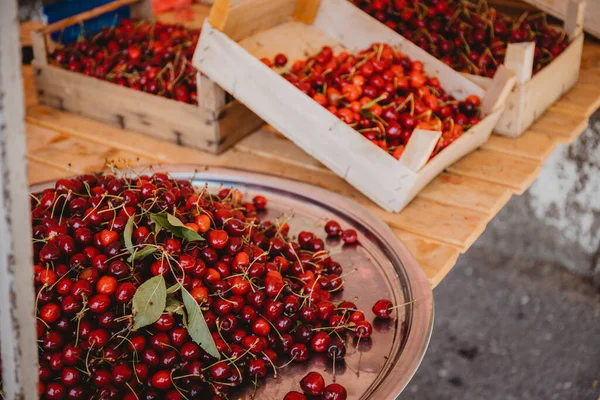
[[262, 44, 481, 159]]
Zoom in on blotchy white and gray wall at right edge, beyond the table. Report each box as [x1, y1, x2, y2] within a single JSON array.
[[476, 110, 600, 287]]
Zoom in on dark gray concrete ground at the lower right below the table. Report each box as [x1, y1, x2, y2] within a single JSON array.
[[400, 247, 600, 400]]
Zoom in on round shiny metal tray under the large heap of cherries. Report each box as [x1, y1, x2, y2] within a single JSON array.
[[32, 165, 433, 400]]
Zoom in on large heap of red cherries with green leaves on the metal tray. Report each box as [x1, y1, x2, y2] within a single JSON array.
[[31, 173, 395, 400]]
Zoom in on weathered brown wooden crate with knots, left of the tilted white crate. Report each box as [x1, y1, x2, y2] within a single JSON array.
[[32, 0, 262, 153]]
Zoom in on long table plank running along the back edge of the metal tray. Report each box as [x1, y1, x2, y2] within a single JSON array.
[[28, 106, 491, 250]]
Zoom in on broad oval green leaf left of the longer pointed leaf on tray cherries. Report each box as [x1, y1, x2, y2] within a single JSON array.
[[133, 275, 167, 330]]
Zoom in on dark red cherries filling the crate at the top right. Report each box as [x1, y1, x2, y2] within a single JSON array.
[[350, 0, 569, 77]]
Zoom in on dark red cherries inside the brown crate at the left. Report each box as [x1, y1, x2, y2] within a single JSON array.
[[49, 19, 200, 104]]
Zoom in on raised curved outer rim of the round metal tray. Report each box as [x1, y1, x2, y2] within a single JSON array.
[[29, 163, 434, 400]]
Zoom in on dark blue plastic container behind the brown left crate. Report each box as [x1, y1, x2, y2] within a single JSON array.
[[42, 0, 130, 44]]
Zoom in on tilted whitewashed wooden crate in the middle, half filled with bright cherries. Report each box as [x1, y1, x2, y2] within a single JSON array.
[[193, 0, 515, 212]]
